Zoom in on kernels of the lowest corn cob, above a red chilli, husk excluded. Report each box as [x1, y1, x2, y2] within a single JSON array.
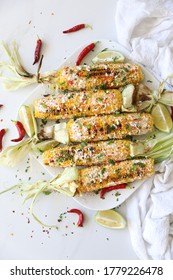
[[77, 159, 154, 193]]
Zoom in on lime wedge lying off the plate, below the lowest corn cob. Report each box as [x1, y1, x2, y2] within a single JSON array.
[[95, 210, 126, 229]]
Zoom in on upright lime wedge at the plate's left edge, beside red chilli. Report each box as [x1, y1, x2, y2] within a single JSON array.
[[19, 105, 37, 137]]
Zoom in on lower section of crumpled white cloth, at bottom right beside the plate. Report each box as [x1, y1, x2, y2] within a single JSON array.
[[126, 159, 173, 260]]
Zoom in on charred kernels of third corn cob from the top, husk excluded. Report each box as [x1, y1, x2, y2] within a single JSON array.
[[67, 113, 153, 142]]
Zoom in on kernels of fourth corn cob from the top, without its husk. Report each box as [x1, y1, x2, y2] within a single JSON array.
[[43, 140, 131, 167]]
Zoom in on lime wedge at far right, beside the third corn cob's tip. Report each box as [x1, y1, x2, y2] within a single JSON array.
[[151, 103, 172, 133]]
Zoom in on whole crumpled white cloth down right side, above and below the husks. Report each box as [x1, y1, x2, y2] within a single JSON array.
[[115, 0, 173, 259]]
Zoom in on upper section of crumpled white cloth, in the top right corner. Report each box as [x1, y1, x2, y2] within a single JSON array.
[[115, 0, 173, 79]]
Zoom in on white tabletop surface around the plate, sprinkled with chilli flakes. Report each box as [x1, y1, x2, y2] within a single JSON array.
[[0, 0, 137, 260]]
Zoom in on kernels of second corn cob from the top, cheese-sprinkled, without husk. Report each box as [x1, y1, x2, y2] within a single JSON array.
[[34, 89, 122, 120]]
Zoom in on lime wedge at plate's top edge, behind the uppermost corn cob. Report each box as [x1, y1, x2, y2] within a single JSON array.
[[92, 51, 124, 63]]
